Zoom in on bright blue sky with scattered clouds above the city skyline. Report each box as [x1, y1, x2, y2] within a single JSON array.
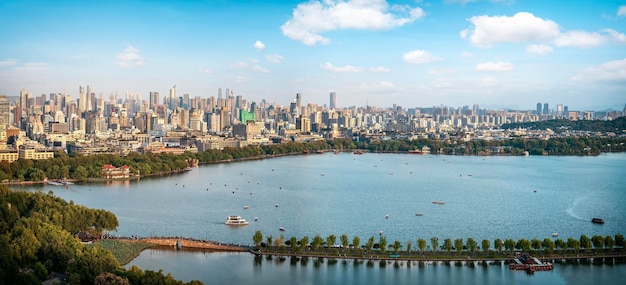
[[0, 0, 626, 110]]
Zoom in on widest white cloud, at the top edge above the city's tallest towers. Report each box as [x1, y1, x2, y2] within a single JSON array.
[[280, 0, 424, 45]]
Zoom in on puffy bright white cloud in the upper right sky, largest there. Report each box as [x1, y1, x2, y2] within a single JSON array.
[[460, 12, 559, 48]]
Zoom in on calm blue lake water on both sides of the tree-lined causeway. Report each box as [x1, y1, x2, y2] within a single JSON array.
[[12, 153, 626, 284]]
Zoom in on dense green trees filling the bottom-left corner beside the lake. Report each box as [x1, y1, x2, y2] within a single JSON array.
[[0, 185, 199, 285]]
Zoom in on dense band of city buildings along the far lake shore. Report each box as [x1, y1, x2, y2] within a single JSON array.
[[0, 85, 626, 161]]
